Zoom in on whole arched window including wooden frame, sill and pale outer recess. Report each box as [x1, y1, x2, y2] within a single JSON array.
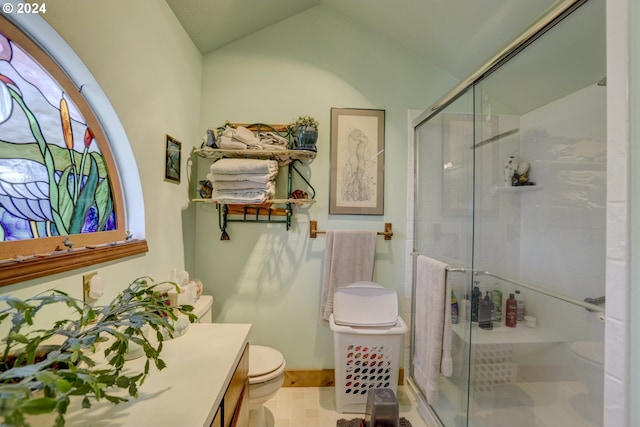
[[0, 16, 147, 286]]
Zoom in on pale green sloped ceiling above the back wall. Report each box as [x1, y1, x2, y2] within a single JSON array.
[[166, 0, 555, 79]]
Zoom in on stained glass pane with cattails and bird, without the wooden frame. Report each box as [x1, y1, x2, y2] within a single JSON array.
[[0, 34, 116, 241]]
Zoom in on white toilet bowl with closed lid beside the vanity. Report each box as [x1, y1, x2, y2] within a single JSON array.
[[249, 344, 285, 427]]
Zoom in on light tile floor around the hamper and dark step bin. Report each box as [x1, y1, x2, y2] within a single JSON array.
[[265, 386, 427, 427]]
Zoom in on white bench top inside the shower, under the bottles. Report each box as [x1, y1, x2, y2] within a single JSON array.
[[451, 323, 565, 345]]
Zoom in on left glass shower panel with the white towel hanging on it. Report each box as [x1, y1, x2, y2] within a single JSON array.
[[411, 92, 475, 426]]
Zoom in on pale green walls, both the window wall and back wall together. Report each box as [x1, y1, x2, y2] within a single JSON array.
[[2, 0, 457, 369]]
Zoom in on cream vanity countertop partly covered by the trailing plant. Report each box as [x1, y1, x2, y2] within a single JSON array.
[[58, 323, 251, 427]]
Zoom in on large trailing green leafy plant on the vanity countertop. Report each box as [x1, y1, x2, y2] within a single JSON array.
[[0, 277, 196, 426]]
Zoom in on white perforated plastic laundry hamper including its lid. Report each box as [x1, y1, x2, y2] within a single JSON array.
[[329, 282, 409, 413]]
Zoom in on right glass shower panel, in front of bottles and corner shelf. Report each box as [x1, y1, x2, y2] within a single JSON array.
[[469, 0, 607, 427]]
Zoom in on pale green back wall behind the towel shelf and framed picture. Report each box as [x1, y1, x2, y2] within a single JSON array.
[[195, 6, 456, 369]]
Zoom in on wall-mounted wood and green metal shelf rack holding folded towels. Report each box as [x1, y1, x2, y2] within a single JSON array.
[[192, 124, 316, 240]]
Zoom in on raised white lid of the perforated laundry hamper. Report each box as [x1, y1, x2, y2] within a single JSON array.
[[333, 281, 398, 327]]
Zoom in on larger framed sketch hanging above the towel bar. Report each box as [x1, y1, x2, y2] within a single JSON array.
[[329, 108, 385, 215]]
